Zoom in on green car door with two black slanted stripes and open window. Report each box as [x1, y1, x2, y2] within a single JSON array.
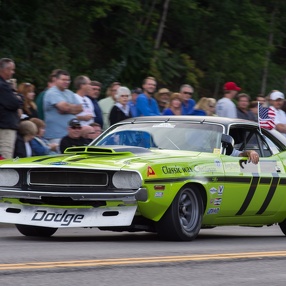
[[220, 125, 285, 223]]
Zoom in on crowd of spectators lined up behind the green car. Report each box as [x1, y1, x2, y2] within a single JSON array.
[[0, 58, 286, 158]]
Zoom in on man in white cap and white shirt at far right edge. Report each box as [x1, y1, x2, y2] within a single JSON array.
[[269, 90, 286, 137]]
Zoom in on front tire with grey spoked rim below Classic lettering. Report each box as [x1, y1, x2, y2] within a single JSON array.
[[157, 187, 203, 241]]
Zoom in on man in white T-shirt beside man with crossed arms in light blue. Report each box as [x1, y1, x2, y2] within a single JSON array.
[[74, 75, 95, 126]]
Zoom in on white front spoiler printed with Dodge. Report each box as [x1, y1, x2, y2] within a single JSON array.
[[0, 203, 137, 228]]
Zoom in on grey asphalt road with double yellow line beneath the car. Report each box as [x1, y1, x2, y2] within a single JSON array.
[[0, 226, 286, 286]]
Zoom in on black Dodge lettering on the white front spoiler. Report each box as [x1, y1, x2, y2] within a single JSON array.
[[32, 210, 84, 226]]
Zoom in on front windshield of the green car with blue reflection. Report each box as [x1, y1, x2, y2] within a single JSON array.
[[93, 123, 223, 153]]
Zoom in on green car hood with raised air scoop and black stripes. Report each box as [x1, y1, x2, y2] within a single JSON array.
[[0, 146, 200, 170]]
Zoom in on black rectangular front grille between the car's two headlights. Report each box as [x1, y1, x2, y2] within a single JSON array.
[[28, 170, 108, 187]]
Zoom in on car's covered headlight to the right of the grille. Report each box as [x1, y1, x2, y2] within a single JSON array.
[[112, 171, 142, 189]]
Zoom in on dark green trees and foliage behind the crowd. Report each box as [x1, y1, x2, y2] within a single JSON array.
[[0, 0, 286, 97]]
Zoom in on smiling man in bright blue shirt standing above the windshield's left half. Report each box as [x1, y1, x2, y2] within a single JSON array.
[[136, 77, 160, 116]]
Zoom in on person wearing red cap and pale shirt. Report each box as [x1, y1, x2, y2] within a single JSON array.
[[216, 82, 241, 118]]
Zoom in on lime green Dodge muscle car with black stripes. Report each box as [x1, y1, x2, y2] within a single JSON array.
[[0, 116, 286, 241]]
